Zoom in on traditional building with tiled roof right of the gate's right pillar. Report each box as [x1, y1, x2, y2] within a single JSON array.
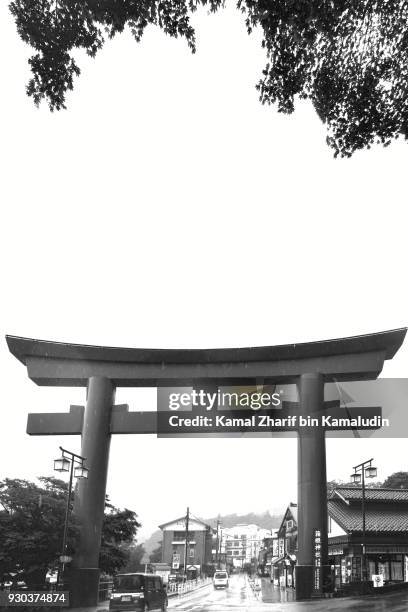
[[328, 486, 408, 584]]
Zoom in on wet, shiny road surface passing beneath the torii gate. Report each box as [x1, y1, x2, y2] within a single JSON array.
[[169, 575, 408, 612]]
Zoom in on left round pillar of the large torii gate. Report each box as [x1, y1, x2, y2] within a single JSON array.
[[71, 376, 114, 606]]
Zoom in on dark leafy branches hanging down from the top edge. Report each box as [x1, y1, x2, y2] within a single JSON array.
[[10, 0, 408, 157]]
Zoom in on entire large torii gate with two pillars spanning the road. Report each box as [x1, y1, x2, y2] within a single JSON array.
[[7, 328, 407, 606]]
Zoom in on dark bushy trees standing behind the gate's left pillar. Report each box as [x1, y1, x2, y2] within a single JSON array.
[[0, 477, 143, 587]]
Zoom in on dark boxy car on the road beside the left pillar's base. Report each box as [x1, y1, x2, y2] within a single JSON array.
[[109, 573, 167, 612]]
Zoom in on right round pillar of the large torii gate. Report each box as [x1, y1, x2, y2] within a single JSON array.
[[296, 373, 328, 599]]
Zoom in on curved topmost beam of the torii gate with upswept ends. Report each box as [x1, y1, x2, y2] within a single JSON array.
[[7, 328, 406, 387]]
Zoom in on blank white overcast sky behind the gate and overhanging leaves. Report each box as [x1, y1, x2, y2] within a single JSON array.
[[0, 2, 408, 536]]
